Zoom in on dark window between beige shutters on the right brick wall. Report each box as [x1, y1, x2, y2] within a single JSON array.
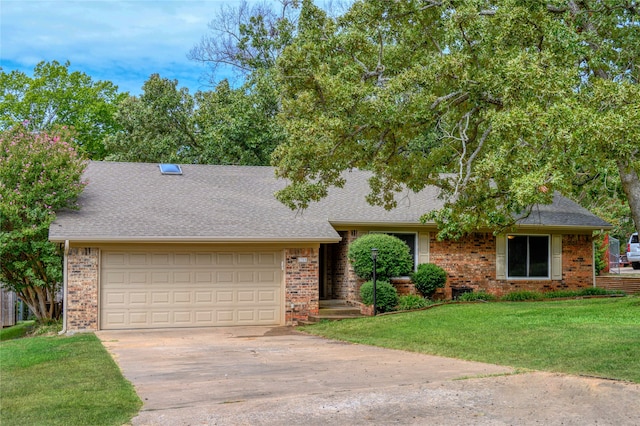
[[507, 235, 550, 278]]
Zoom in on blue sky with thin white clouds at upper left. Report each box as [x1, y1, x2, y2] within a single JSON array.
[[0, 0, 250, 95]]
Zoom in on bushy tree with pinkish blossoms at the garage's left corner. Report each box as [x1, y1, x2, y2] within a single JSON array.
[[0, 125, 85, 321]]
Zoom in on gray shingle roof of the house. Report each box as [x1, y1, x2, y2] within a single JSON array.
[[49, 162, 609, 242]]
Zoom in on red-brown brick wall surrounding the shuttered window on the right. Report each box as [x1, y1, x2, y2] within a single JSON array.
[[430, 233, 593, 299]]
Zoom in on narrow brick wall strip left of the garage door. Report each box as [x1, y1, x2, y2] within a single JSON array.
[[66, 247, 100, 331]]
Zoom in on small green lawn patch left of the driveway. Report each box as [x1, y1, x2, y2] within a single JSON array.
[[0, 334, 142, 426]]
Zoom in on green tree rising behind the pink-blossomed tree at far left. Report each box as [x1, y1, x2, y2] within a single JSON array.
[[0, 61, 126, 160]]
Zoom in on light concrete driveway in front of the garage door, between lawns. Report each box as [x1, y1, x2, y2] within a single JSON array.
[[97, 327, 640, 425]]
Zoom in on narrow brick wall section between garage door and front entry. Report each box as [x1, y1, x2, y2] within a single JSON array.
[[285, 248, 320, 325]]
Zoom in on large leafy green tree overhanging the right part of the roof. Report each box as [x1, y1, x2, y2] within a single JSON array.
[[274, 0, 640, 237]]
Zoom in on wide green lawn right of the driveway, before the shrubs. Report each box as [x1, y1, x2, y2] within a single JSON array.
[[301, 297, 640, 383]]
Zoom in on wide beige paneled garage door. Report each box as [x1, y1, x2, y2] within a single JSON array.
[[100, 250, 283, 330]]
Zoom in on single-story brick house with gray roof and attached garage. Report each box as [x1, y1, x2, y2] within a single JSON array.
[[49, 162, 610, 331]]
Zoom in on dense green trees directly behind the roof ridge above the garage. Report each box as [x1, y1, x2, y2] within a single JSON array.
[[105, 74, 283, 165]]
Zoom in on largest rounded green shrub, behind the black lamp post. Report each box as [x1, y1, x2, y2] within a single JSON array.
[[348, 234, 413, 280]]
